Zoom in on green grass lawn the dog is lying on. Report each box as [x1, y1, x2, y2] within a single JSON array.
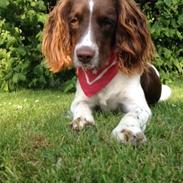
[[0, 78, 183, 183]]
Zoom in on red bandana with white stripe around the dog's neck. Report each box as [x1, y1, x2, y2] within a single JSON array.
[[77, 54, 118, 97]]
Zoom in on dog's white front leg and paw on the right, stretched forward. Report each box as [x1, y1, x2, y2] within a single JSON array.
[[112, 102, 151, 145]]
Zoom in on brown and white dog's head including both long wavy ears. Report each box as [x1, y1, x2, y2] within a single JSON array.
[[42, 0, 154, 73]]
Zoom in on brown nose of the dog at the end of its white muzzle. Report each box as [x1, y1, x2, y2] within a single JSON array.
[[76, 46, 95, 64]]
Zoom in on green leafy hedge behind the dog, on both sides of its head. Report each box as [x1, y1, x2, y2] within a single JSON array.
[[0, 0, 183, 91]]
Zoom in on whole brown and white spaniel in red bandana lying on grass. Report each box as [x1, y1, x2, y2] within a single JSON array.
[[42, 0, 171, 145]]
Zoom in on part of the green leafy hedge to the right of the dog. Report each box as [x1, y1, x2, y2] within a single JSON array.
[[143, 0, 183, 79]]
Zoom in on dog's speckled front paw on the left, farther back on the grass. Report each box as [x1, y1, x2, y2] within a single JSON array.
[[70, 118, 95, 131]]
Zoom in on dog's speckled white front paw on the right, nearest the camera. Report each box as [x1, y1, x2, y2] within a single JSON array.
[[112, 128, 146, 145]]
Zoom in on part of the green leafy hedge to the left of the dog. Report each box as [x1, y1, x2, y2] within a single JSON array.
[[0, 0, 64, 91]]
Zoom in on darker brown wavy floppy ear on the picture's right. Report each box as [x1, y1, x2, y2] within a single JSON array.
[[116, 0, 154, 74]]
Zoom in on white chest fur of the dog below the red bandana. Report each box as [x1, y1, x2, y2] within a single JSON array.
[[75, 72, 144, 111]]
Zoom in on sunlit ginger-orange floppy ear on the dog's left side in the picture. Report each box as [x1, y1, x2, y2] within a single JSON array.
[[42, 0, 72, 72]]
